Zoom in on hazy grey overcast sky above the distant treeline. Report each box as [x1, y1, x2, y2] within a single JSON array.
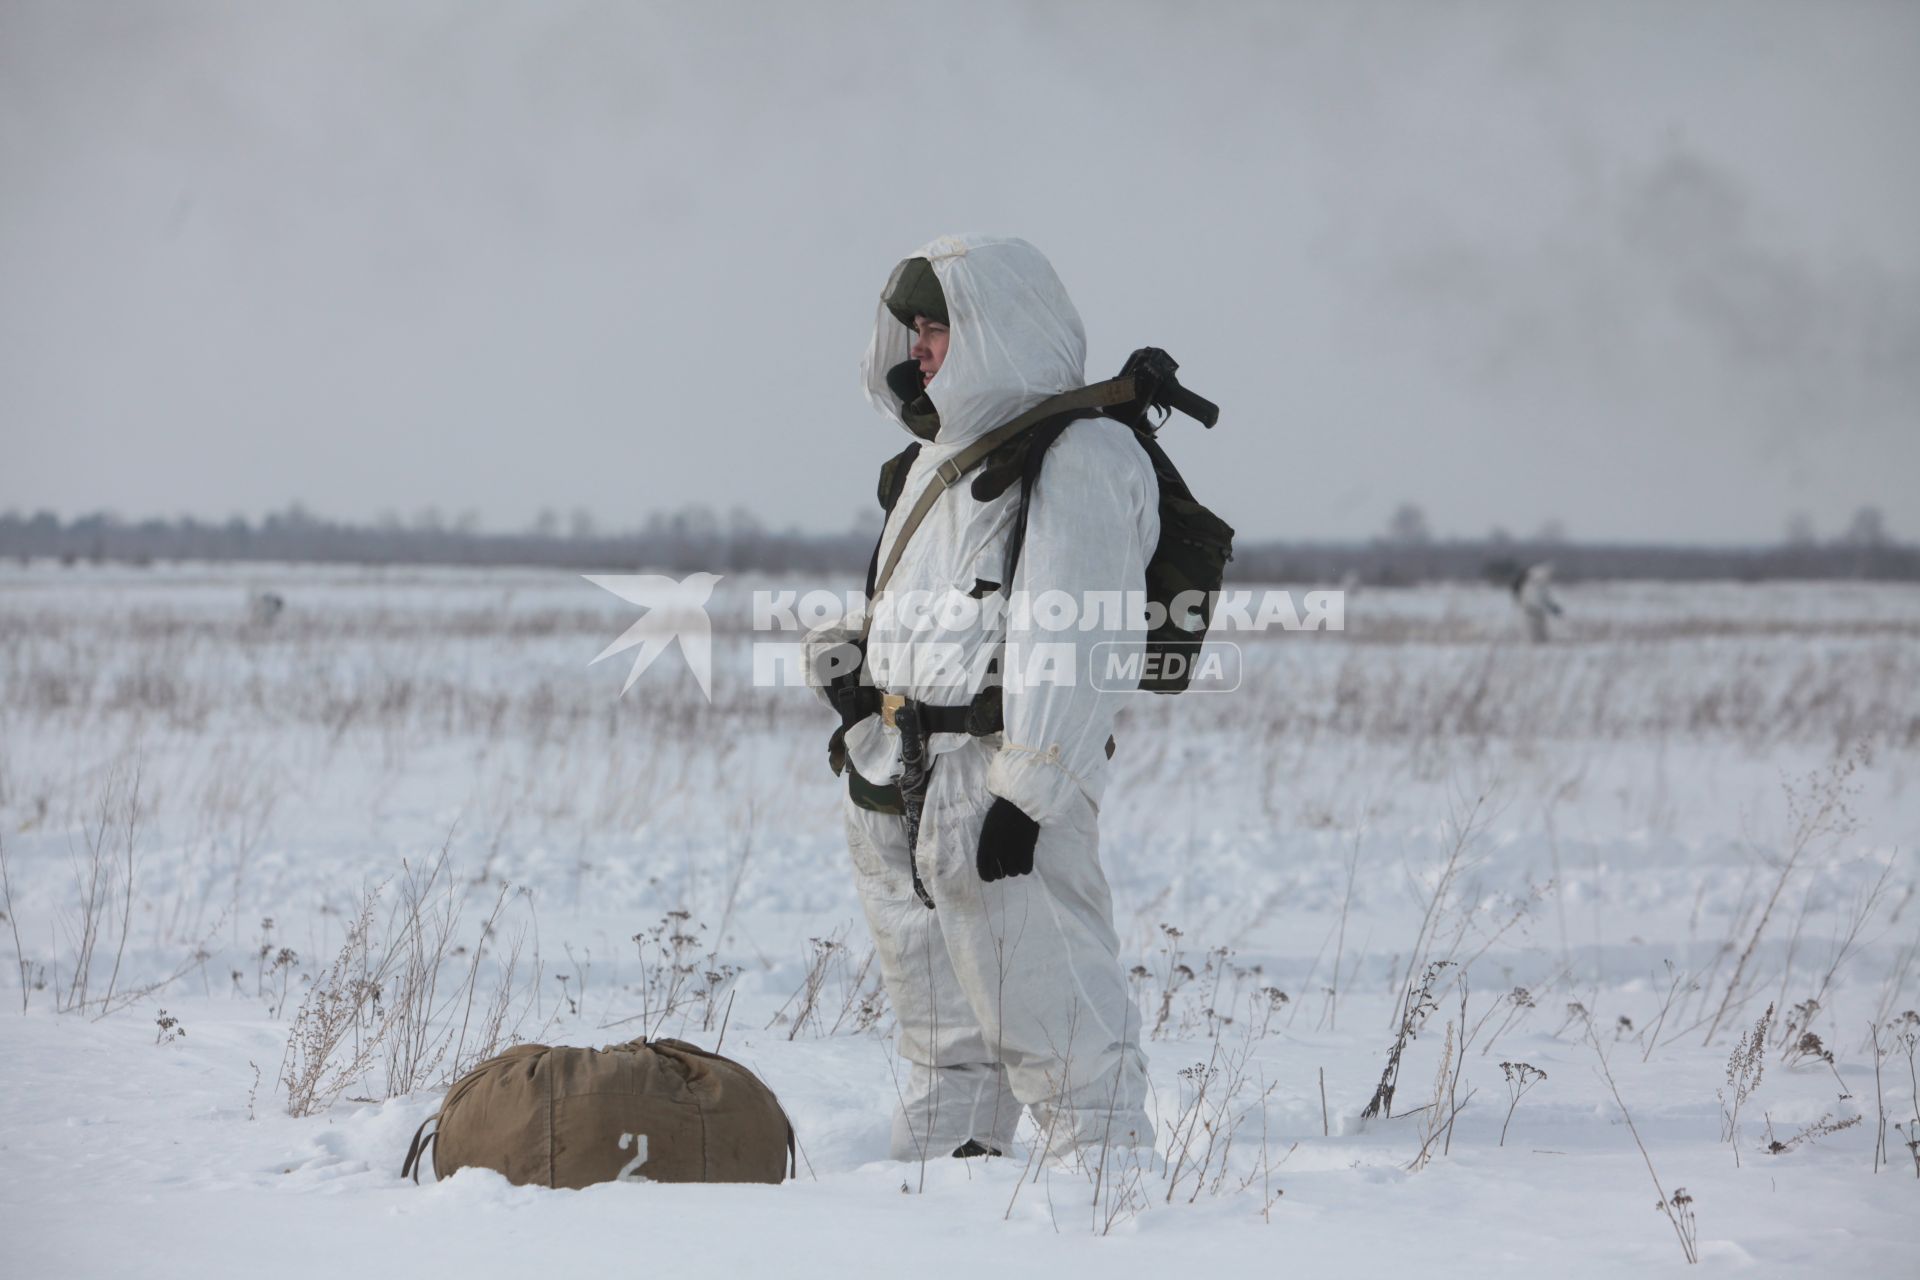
[[0, 0, 1920, 541]]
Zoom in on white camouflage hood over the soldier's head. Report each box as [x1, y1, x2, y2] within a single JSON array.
[[860, 234, 1087, 447]]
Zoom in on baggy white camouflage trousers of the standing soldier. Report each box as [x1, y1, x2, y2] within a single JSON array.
[[845, 739, 1154, 1159]]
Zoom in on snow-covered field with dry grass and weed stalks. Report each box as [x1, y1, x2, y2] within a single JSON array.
[[0, 564, 1920, 1278]]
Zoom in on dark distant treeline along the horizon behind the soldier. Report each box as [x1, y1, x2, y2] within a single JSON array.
[[0, 507, 1920, 585]]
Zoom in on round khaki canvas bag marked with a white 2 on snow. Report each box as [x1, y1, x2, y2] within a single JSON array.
[[399, 1040, 795, 1188]]
